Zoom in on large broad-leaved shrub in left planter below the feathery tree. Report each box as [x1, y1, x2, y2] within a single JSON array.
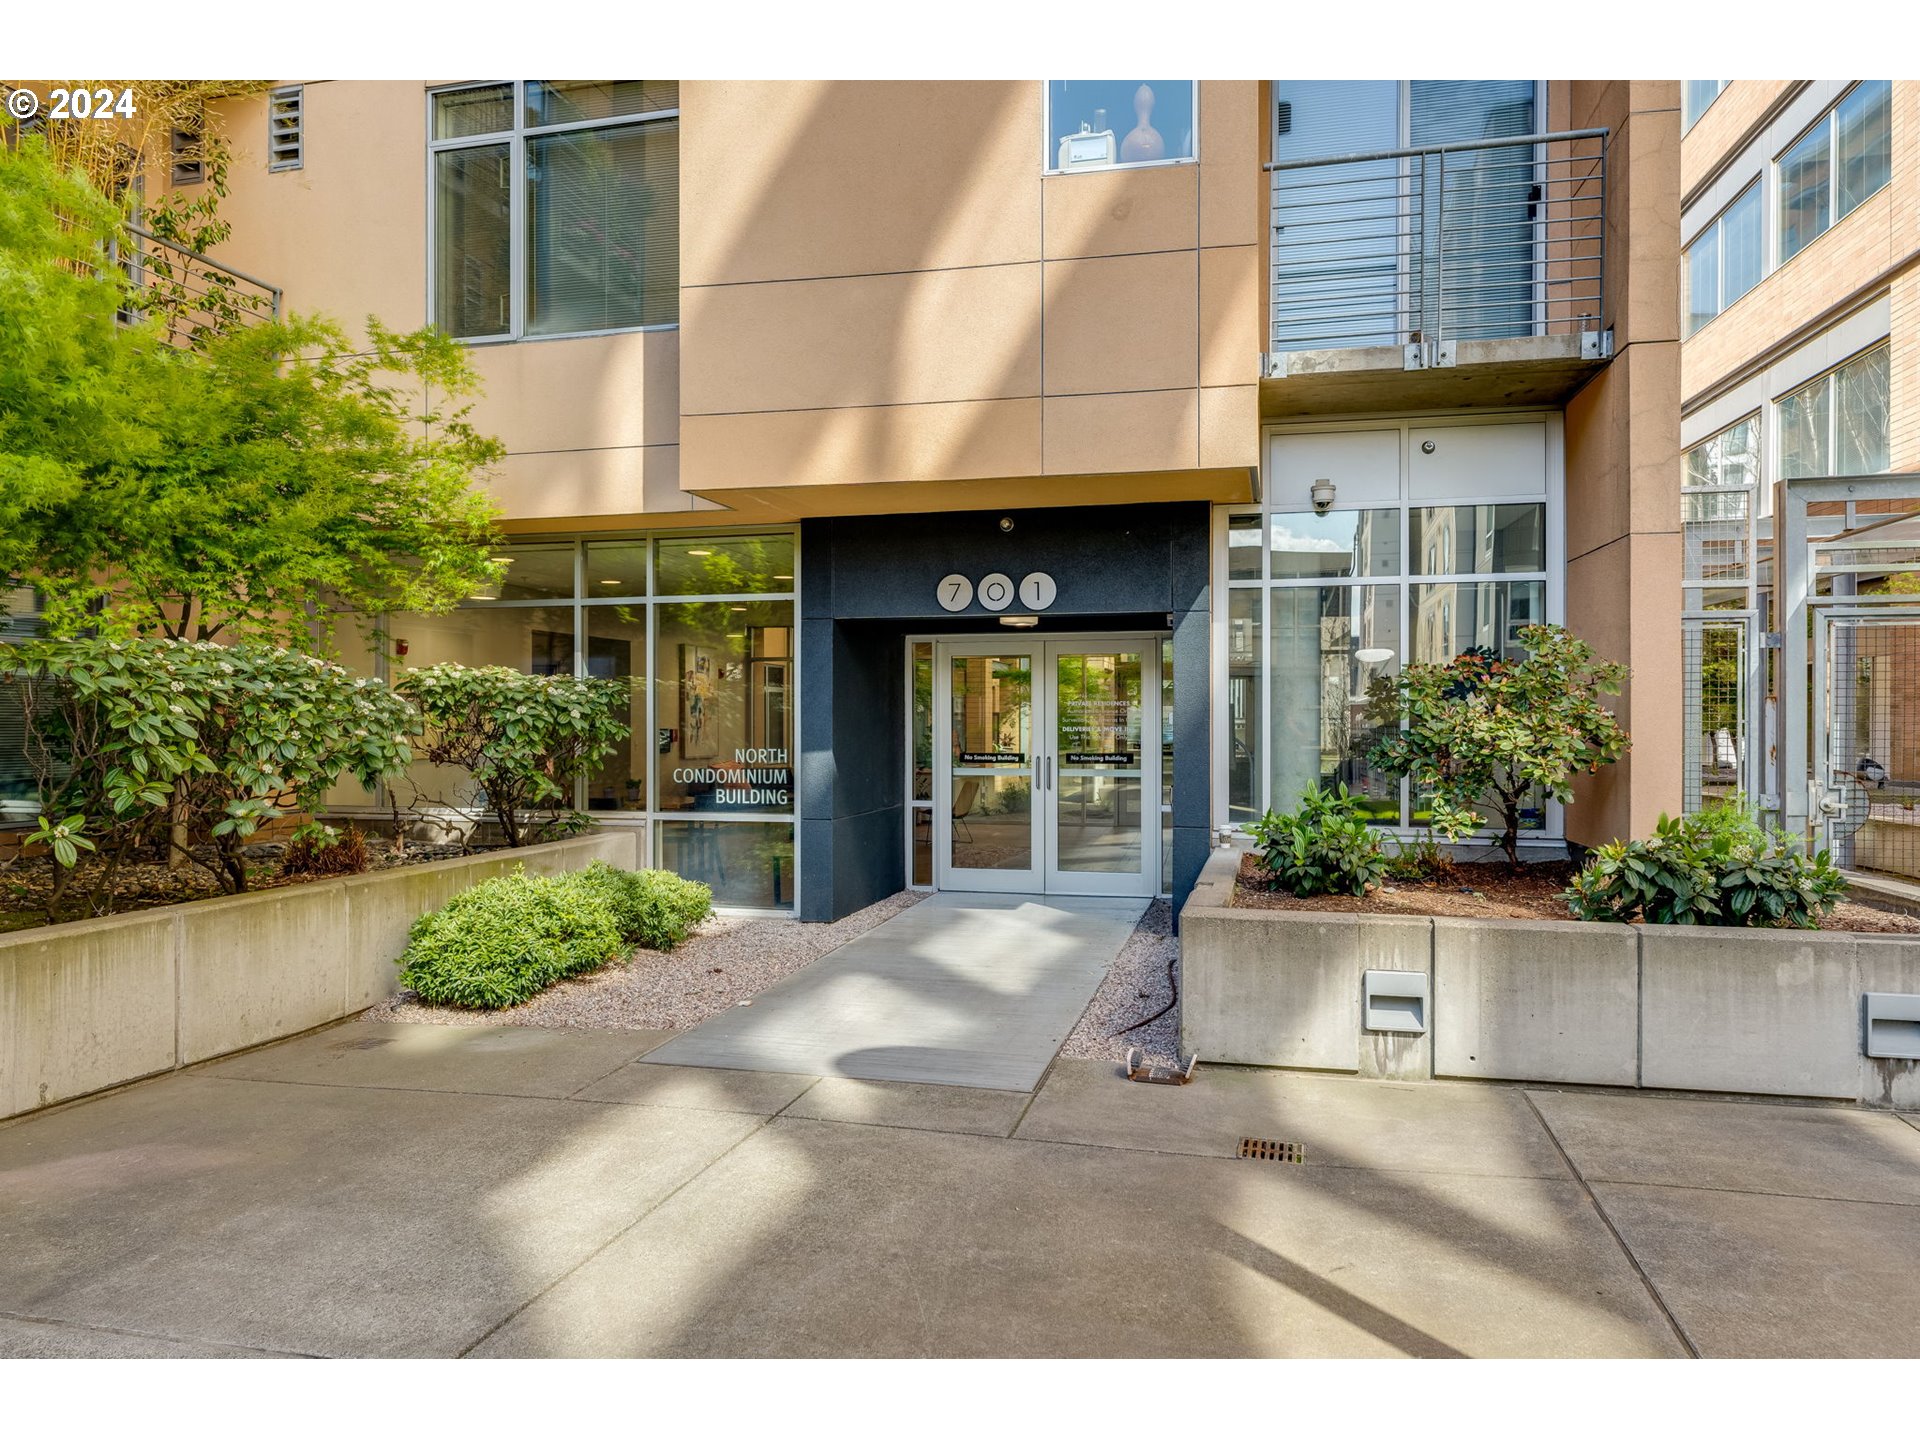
[[0, 639, 415, 920]]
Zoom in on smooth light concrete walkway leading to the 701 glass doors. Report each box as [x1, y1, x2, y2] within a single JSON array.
[[633, 891, 1146, 1091]]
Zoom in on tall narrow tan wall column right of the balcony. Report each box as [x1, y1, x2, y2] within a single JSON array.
[[1567, 81, 1682, 845]]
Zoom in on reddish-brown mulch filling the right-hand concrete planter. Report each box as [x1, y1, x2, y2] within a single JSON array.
[[1233, 854, 1920, 935]]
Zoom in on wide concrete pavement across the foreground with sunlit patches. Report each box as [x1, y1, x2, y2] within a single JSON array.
[[0, 1023, 1920, 1356]]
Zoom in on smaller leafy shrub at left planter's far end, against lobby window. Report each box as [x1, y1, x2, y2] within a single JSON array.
[[397, 664, 632, 847]]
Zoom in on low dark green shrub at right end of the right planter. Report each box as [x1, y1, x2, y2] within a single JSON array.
[[1567, 797, 1847, 929]]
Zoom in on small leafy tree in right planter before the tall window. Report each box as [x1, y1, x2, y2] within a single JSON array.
[[1371, 626, 1628, 868]]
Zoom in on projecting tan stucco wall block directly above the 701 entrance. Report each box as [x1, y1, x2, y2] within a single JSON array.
[[680, 81, 1263, 513]]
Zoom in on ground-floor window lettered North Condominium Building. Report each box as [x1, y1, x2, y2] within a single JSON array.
[[374, 529, 799, 906]]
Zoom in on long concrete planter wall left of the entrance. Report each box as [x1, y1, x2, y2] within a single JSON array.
[[0, 829, 643, 1117]]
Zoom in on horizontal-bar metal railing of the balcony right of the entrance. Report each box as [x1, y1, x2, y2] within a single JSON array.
[[1267, 129, 1607, 374]]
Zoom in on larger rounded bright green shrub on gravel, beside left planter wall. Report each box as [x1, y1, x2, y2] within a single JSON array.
[[399, 872, 626, 1010]]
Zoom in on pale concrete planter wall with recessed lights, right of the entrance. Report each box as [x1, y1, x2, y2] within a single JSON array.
[[1181, 851, 1920, 1108]]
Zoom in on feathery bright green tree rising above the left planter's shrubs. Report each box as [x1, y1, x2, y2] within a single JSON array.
[[0, 138, 501, 647]]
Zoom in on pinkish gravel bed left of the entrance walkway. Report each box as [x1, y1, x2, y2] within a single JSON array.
[[363, 891, 925, 1029]]
